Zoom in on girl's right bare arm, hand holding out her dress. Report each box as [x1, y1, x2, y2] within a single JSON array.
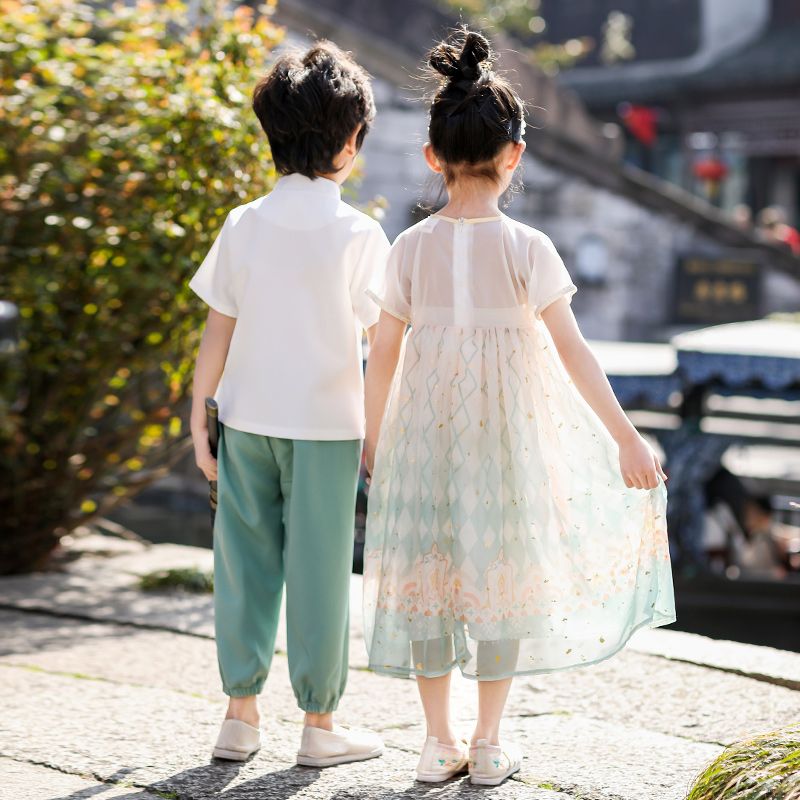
[[542, 298, 666, 489]]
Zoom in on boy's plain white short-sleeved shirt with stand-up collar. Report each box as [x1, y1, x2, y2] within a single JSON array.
[[189, 174, 389, 440]]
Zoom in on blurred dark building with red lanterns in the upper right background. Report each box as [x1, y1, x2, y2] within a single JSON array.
[[552, 0, 800, 226]]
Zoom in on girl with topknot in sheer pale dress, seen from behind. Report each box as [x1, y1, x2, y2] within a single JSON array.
[[364, 31, 675, 785]]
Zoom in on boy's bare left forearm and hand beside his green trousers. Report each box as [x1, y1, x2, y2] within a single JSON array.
[[190, 308, 236, 481]]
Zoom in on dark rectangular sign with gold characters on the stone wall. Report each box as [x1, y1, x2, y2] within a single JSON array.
[[673, 254, 761, 324]]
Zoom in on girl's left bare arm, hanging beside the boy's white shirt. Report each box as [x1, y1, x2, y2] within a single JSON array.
[[364, 311, 406, 472]]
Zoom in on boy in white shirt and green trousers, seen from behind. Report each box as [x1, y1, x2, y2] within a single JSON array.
[[189, 41, 389, 767]]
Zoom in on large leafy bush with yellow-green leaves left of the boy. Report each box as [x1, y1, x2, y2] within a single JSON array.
[[0, 0, 281, 573]]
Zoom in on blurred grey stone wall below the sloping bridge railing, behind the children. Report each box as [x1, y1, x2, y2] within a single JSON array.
[[357, 71, 800, 341]]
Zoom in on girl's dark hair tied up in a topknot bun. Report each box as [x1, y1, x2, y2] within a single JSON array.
[[428, 28, 525, 183]]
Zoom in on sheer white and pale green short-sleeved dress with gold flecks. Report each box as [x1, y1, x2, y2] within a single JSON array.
[[364, 215, 675, 679]]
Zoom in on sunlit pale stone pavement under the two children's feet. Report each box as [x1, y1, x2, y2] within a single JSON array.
[[0, 536, 800, 800]]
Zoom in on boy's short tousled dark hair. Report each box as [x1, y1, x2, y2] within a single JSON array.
[[253, 40, 375, 178]]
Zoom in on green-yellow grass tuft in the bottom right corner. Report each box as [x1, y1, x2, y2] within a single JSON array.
[[686, 724, 800, 800]]
